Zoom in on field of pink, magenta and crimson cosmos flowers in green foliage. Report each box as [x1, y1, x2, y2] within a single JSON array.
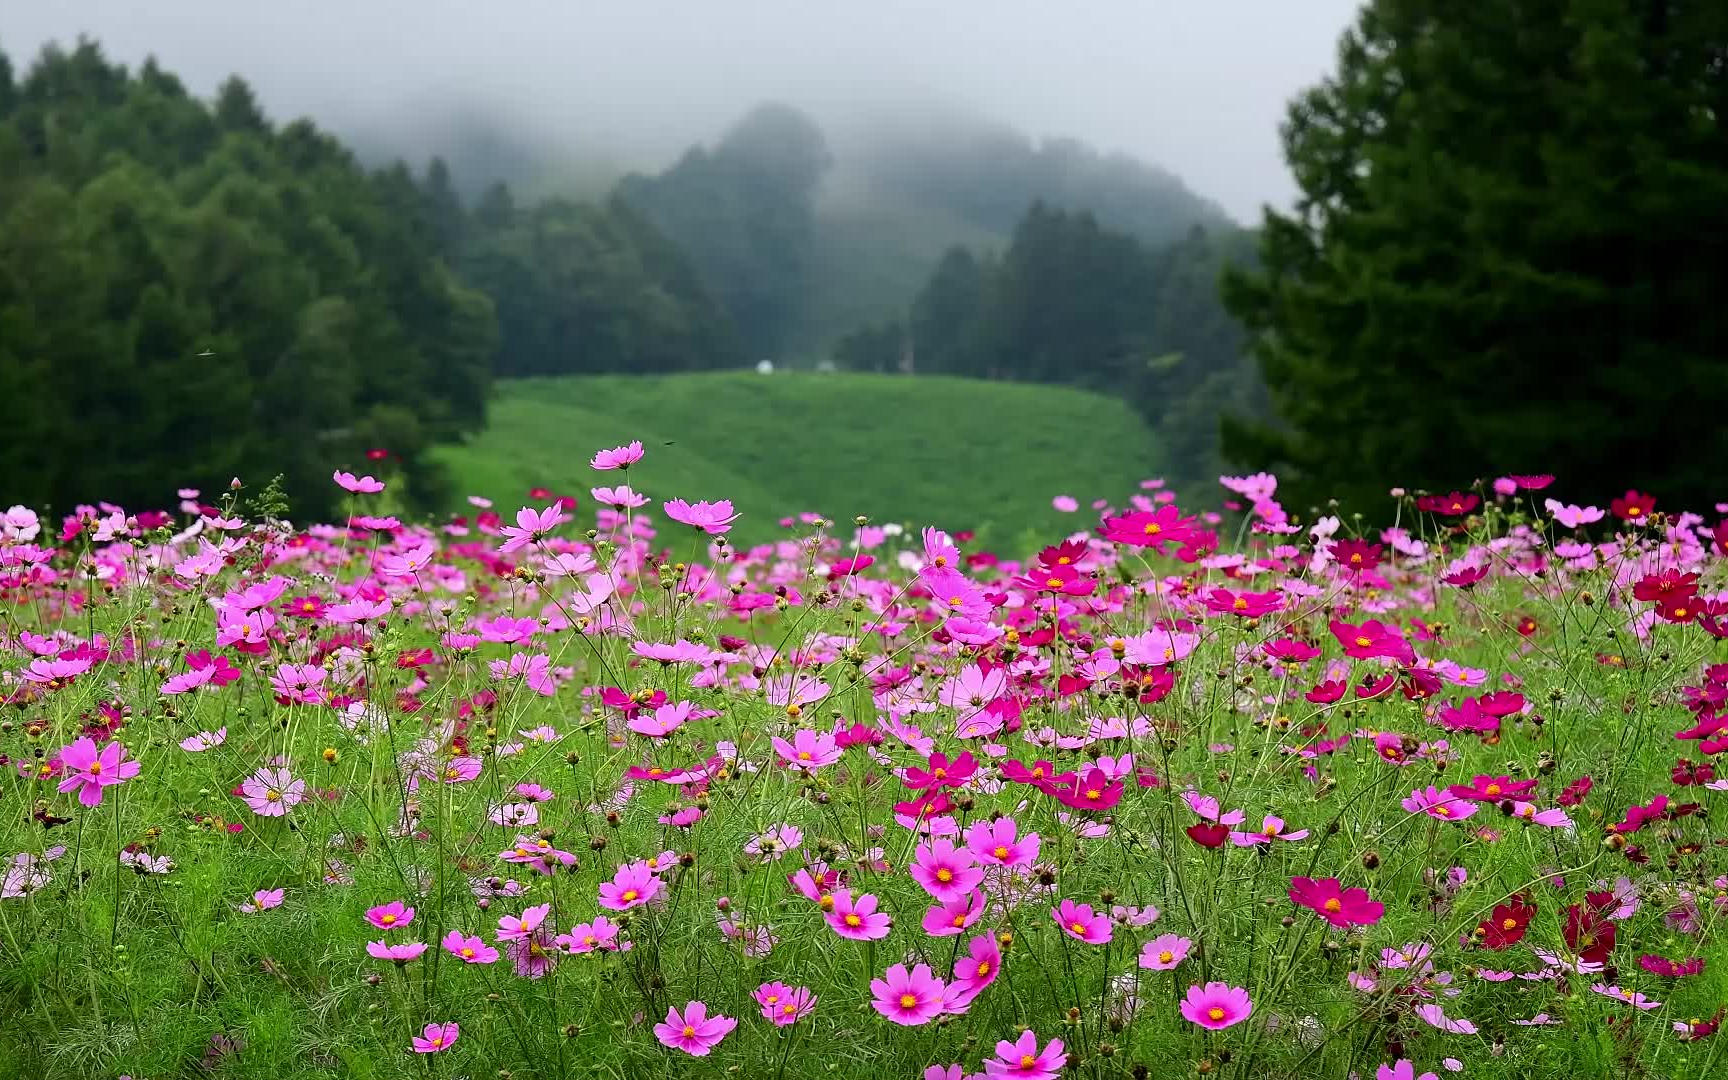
[[0, 444, 1728, 1080]]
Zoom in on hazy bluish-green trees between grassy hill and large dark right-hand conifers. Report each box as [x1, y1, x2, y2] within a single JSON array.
[[833, 202, 1267, 480]]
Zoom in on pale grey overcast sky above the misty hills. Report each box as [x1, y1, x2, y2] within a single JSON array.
[[0, 0, 1358, 221]]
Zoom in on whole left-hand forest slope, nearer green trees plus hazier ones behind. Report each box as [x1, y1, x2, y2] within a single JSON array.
[[0, 41, 741, 513]]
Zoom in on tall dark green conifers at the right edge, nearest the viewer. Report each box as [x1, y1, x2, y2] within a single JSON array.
[[1229, 0, 1728, 511]]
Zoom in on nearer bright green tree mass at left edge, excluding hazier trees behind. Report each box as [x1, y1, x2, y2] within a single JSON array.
[[0, 41, 496, 510]]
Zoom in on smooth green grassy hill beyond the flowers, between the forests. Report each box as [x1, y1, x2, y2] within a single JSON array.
[[430, 372, 1161, 546]]
